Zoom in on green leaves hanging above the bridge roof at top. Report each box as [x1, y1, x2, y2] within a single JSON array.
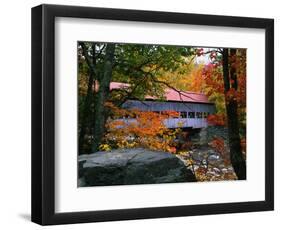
[[112, 44, 190, 100]]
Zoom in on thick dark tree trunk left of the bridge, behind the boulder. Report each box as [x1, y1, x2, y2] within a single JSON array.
[[92, 43, 115, 152]]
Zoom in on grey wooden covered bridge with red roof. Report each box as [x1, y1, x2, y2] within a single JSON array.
[[110, 82, 215, 128]]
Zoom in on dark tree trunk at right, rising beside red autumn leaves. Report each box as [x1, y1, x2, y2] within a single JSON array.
[[223, 49, 246, 180]]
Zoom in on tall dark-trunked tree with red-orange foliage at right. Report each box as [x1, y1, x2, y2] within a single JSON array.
[[184, 48, 246, 180]]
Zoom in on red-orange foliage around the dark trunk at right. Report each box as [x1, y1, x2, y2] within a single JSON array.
[[202, 49, 246, 127]]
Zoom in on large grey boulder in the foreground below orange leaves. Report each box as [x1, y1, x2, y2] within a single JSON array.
[[78, 148, 196, 186]]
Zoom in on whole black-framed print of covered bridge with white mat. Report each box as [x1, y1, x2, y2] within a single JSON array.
[[32, 5, 274, 225]]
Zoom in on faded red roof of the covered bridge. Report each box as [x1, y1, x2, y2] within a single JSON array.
[[110, 82, 210, 103]]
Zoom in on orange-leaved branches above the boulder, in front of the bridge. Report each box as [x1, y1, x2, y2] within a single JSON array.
[[101, 103, 180, 153]]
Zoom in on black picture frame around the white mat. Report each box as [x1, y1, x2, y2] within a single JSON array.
[[31, 5, 274, 225]]
